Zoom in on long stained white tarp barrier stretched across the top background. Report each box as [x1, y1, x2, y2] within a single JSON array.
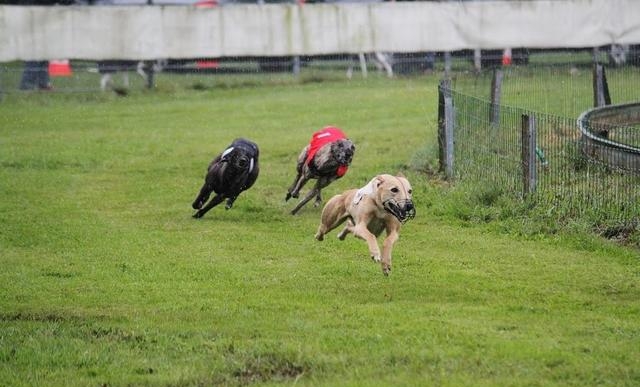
[[0, 0, 640, 61]]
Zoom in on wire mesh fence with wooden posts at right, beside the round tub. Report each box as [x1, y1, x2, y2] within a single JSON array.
[[440, 60, 640, 226]]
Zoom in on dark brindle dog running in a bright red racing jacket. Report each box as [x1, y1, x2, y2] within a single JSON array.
[[285, 126, 356, 215]]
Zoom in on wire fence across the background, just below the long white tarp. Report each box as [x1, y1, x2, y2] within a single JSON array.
[[0, 45, 640, 95]]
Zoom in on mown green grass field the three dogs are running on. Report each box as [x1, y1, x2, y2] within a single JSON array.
[[0, 76, 640, 387]]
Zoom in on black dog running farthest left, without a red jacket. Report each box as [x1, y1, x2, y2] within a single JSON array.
[[191, 138, 260, 218]]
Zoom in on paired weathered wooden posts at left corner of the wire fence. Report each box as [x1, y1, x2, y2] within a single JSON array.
[[438, 79, 454, 180]]
